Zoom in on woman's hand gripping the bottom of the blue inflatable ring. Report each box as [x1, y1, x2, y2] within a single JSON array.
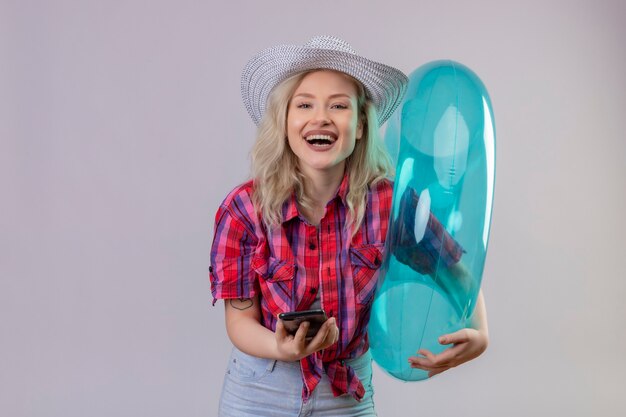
[[409, 328, 489, 378]]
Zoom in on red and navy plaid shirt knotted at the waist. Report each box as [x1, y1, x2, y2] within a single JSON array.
[[209, 175, 460, 400]]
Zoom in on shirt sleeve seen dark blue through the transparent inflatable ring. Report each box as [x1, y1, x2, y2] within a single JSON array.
[[392, 187, 465, 275]]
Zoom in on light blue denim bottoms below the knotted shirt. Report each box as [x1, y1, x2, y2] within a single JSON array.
[[218, 348, 376, 417]]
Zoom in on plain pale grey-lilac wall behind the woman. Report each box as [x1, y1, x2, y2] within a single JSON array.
[[0, 0, 626, 417]]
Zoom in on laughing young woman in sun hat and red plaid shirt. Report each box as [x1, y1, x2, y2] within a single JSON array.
[[210, 36, 488, 417]]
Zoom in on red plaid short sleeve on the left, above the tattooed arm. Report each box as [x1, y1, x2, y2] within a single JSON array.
[[209, 205, 258, 305]]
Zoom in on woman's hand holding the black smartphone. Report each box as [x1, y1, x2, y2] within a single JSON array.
[[275, 317, 339, 362]]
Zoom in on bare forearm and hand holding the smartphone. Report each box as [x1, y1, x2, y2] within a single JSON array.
[[224, 296, 339, 361]]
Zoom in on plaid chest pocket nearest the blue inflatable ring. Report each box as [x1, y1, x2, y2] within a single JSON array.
[[350, 243, 383, 304]]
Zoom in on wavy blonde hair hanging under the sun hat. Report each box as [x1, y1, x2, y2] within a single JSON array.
[[251, 70, 392, 236]]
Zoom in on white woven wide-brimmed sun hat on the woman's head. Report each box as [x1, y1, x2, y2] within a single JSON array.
[[241, 36, 409, 126]]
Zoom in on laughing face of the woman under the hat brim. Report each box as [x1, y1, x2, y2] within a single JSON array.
[[287, 70, 363, 178]]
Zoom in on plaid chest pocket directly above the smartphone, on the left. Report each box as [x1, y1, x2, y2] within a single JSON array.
[[252, 256, 296, 302]]
